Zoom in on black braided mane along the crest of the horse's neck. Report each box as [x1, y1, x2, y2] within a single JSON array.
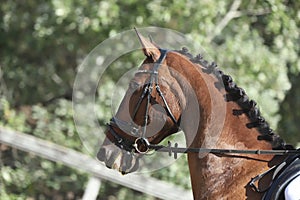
[[176, 47, 293, 149]]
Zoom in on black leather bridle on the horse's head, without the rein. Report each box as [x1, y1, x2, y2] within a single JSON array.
[[107, 49, 179, 154]]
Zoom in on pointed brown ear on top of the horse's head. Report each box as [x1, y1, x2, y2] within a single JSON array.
[[134, 28, 160, 62]]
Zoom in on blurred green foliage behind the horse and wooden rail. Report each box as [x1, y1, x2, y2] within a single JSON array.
[[0, 0, 300, 200]]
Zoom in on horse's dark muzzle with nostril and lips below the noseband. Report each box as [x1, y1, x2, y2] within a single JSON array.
[[97, 145, 139, 175]]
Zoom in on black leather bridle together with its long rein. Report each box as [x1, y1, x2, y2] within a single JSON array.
[[106, 49, 300, 156]]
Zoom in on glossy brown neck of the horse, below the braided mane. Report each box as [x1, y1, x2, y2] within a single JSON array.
[[168, 52, 282, 199]]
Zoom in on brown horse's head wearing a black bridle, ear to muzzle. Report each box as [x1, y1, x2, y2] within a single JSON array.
[[97, 32, 185, 174]]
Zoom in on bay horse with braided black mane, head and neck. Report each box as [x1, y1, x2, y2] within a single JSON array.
[[97, 32, 291, 200]]
